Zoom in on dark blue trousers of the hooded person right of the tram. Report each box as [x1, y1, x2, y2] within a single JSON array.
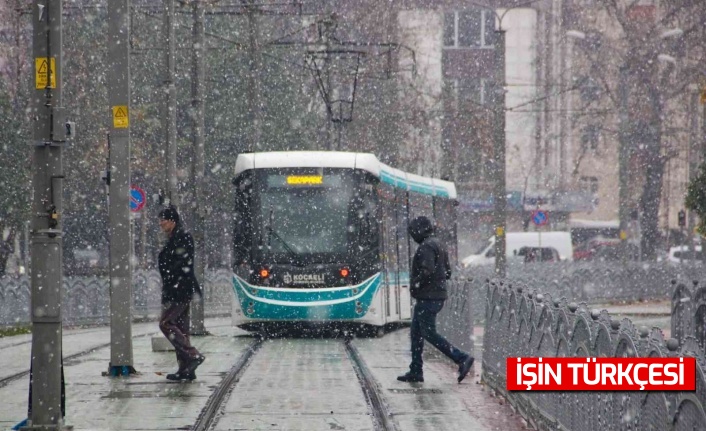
[[409, 299, 468, 375]]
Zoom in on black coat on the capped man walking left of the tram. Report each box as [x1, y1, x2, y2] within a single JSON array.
[[159, 227, 201, 304]]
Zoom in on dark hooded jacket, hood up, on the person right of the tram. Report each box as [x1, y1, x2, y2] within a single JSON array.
[[409, 220, 451, 300]]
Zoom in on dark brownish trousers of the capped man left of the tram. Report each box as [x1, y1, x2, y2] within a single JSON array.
[[159, 302, 200, 372]]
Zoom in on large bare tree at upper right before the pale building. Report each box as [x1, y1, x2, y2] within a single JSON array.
[[563, 0, 706, 258]]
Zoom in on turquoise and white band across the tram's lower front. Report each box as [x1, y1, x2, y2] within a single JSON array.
[[233, 273, 381, 320]]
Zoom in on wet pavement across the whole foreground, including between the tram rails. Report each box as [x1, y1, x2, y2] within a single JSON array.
[[0, 319, 525, 431]]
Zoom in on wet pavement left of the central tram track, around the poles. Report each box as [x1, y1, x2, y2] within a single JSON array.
[[0, 319, 250, 430]]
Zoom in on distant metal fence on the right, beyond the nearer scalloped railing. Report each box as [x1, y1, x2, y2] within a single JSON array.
[[461, 262, 706, 320]]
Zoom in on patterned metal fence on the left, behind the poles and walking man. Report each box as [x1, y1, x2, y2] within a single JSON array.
[[0, 270, 233, 326]]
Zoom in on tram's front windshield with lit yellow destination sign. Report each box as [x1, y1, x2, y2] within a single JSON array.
[[232, 168, 374, 263]]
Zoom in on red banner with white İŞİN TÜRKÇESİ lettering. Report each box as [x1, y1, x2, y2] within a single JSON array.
[[506, 358, 696, 391]]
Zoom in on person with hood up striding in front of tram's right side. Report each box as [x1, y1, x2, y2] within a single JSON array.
[[397, 217, 473, 383]]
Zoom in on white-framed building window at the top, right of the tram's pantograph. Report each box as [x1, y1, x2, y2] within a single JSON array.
[[444, 9, 495, 48]]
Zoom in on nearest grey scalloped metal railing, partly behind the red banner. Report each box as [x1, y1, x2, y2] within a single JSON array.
[[482, 281, 706, 431]]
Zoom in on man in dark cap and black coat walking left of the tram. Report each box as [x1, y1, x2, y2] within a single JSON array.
[[159, 206, 206, 380]]
